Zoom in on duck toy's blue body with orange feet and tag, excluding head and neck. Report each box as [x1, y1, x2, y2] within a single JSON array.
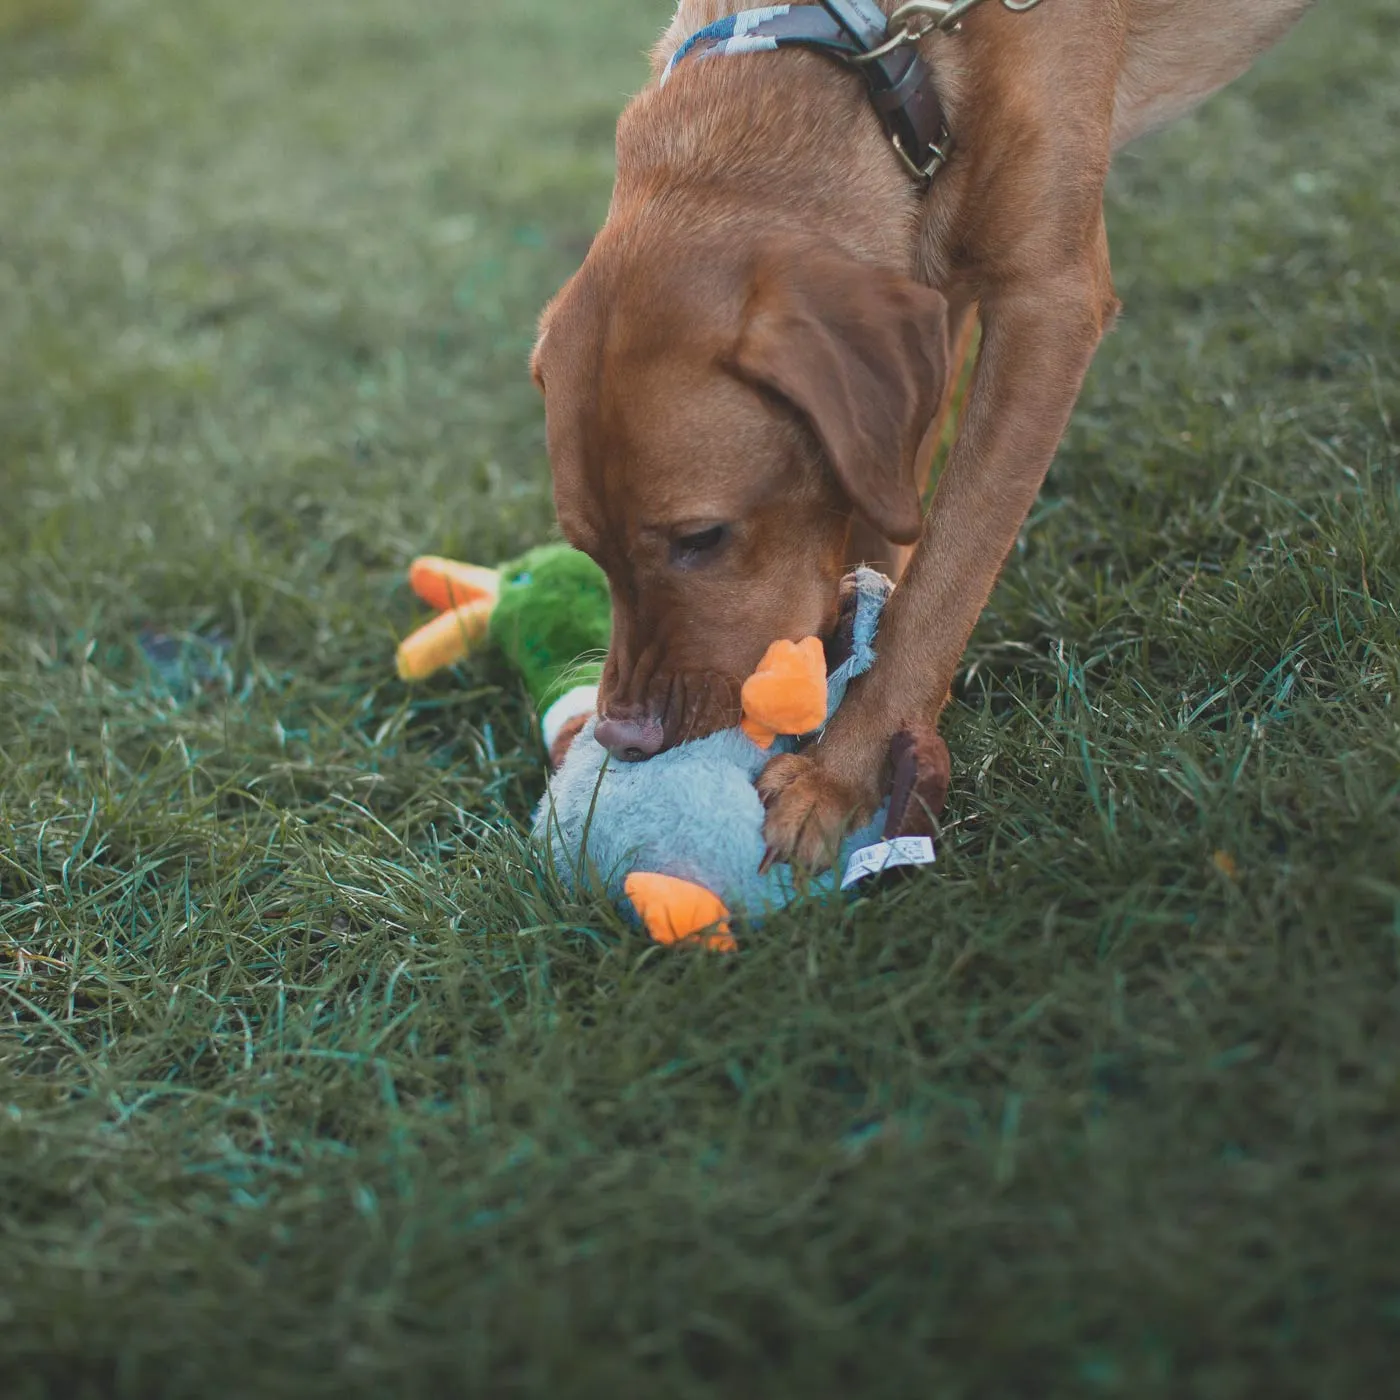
[[533, 570, 948, 949]]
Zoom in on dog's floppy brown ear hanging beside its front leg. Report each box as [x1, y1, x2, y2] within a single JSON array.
[[732, 244, 949, 545]]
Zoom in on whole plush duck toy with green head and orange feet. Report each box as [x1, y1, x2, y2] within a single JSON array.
[[399, 546, 948, 951]]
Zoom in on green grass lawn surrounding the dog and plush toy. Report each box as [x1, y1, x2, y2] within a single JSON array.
[[0, 0, 1400, 1400]]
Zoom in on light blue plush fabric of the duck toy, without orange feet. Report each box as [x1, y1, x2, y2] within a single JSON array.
[[533, 568, 890, 923]]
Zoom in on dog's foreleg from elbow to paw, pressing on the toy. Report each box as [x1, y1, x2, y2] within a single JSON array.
[[759, 242, 1117, 869]]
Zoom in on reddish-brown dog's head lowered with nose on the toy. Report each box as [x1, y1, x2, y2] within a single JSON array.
[[532, 223, 948, 759]]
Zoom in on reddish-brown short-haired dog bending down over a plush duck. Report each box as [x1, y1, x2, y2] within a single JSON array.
[[533, 0, 1310, 867]]
